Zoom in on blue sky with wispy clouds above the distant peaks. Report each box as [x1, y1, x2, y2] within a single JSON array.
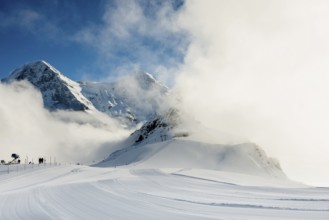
[[0, 0, 188, 81]]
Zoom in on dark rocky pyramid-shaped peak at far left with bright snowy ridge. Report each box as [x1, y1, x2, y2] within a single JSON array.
[[2, 61, 95, 111]]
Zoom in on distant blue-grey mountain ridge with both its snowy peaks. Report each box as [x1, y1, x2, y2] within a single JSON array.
[[2, 61, 168, 126]]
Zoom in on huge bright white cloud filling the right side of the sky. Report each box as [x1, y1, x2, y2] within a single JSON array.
[[176, 0, 329, 185]]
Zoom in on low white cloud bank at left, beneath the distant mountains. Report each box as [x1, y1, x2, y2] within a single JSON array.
[[0, 82, 130, 163]]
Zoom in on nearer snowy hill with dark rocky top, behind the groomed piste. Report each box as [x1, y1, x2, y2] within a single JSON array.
[[98, 109, 285, 178]]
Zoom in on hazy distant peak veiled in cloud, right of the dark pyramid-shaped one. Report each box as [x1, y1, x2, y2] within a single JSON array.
[[81, 72, 168, 124]]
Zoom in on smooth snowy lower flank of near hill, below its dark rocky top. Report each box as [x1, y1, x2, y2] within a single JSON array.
[[98, 138, 285, 178]]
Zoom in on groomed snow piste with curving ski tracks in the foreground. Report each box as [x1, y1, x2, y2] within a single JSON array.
[[0, 165, 329, 220]]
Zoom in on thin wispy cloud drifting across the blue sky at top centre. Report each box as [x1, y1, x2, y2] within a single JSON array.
[[73, 1, 186, 79]]
